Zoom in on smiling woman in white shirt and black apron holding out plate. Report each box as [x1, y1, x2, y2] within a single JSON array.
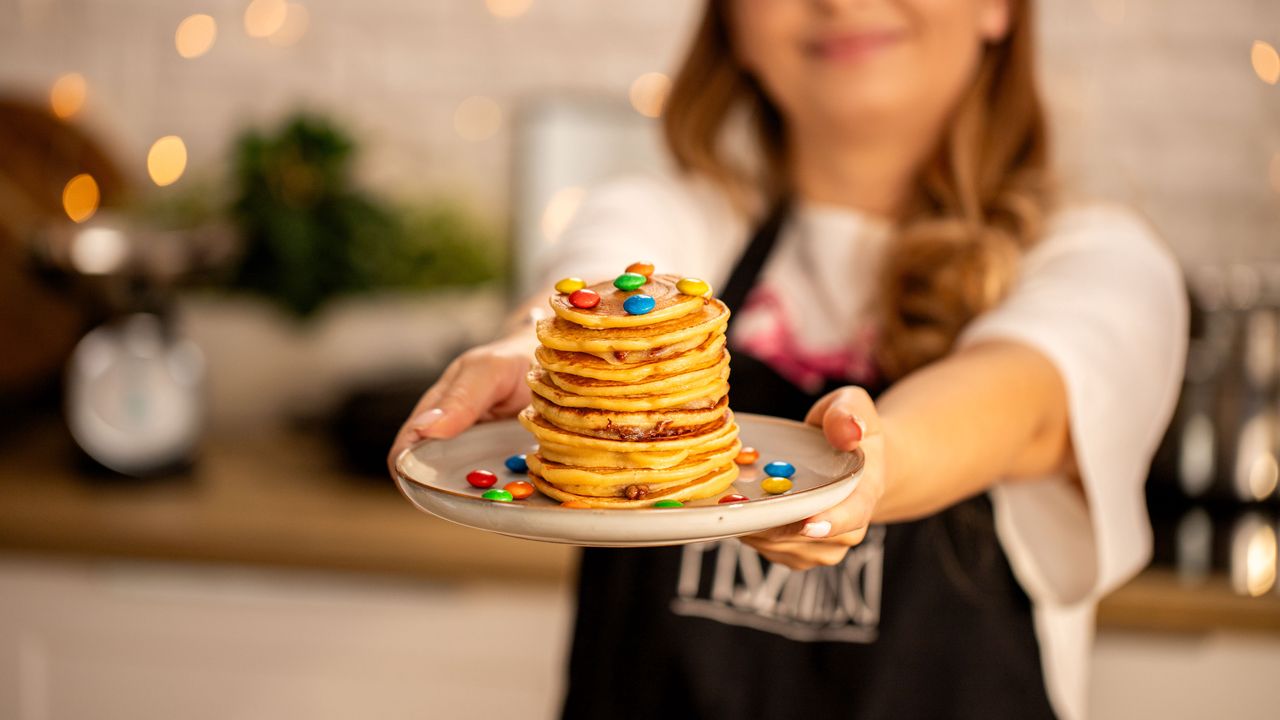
[[393, 0, 1185, 719]]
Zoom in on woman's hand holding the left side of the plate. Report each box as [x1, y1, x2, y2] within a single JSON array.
[[387, 333, 535, 475]]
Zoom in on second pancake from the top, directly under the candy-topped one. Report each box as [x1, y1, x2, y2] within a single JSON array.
[[536, 299, 728, 352]]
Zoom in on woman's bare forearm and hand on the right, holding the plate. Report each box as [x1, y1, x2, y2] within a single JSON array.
[[744, 341, 1070, 570]]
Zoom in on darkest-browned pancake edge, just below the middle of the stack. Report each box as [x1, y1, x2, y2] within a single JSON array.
[[530, 395, 728, 441]]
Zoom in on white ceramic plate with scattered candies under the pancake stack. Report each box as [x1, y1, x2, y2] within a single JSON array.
[[396, 413, 863, 547]]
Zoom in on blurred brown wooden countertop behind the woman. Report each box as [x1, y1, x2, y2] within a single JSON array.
[[0, 420, 1280, 633]]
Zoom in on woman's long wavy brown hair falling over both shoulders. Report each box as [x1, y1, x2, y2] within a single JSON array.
[[663, 0, 1050, 378]]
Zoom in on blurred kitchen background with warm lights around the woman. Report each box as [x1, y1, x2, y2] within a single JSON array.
[[0, 0, 1280, 720]]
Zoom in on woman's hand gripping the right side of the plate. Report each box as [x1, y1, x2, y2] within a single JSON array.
[[742, 386, 884, 570]]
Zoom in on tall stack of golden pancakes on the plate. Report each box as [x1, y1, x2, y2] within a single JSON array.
[[520, 269, 741, 507]]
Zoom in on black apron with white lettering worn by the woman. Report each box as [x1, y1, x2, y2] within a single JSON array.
[[563, 208, 1053, 720]]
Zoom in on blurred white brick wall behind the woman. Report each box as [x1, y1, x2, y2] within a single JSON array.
[[0, 0, 1280, 264]]
